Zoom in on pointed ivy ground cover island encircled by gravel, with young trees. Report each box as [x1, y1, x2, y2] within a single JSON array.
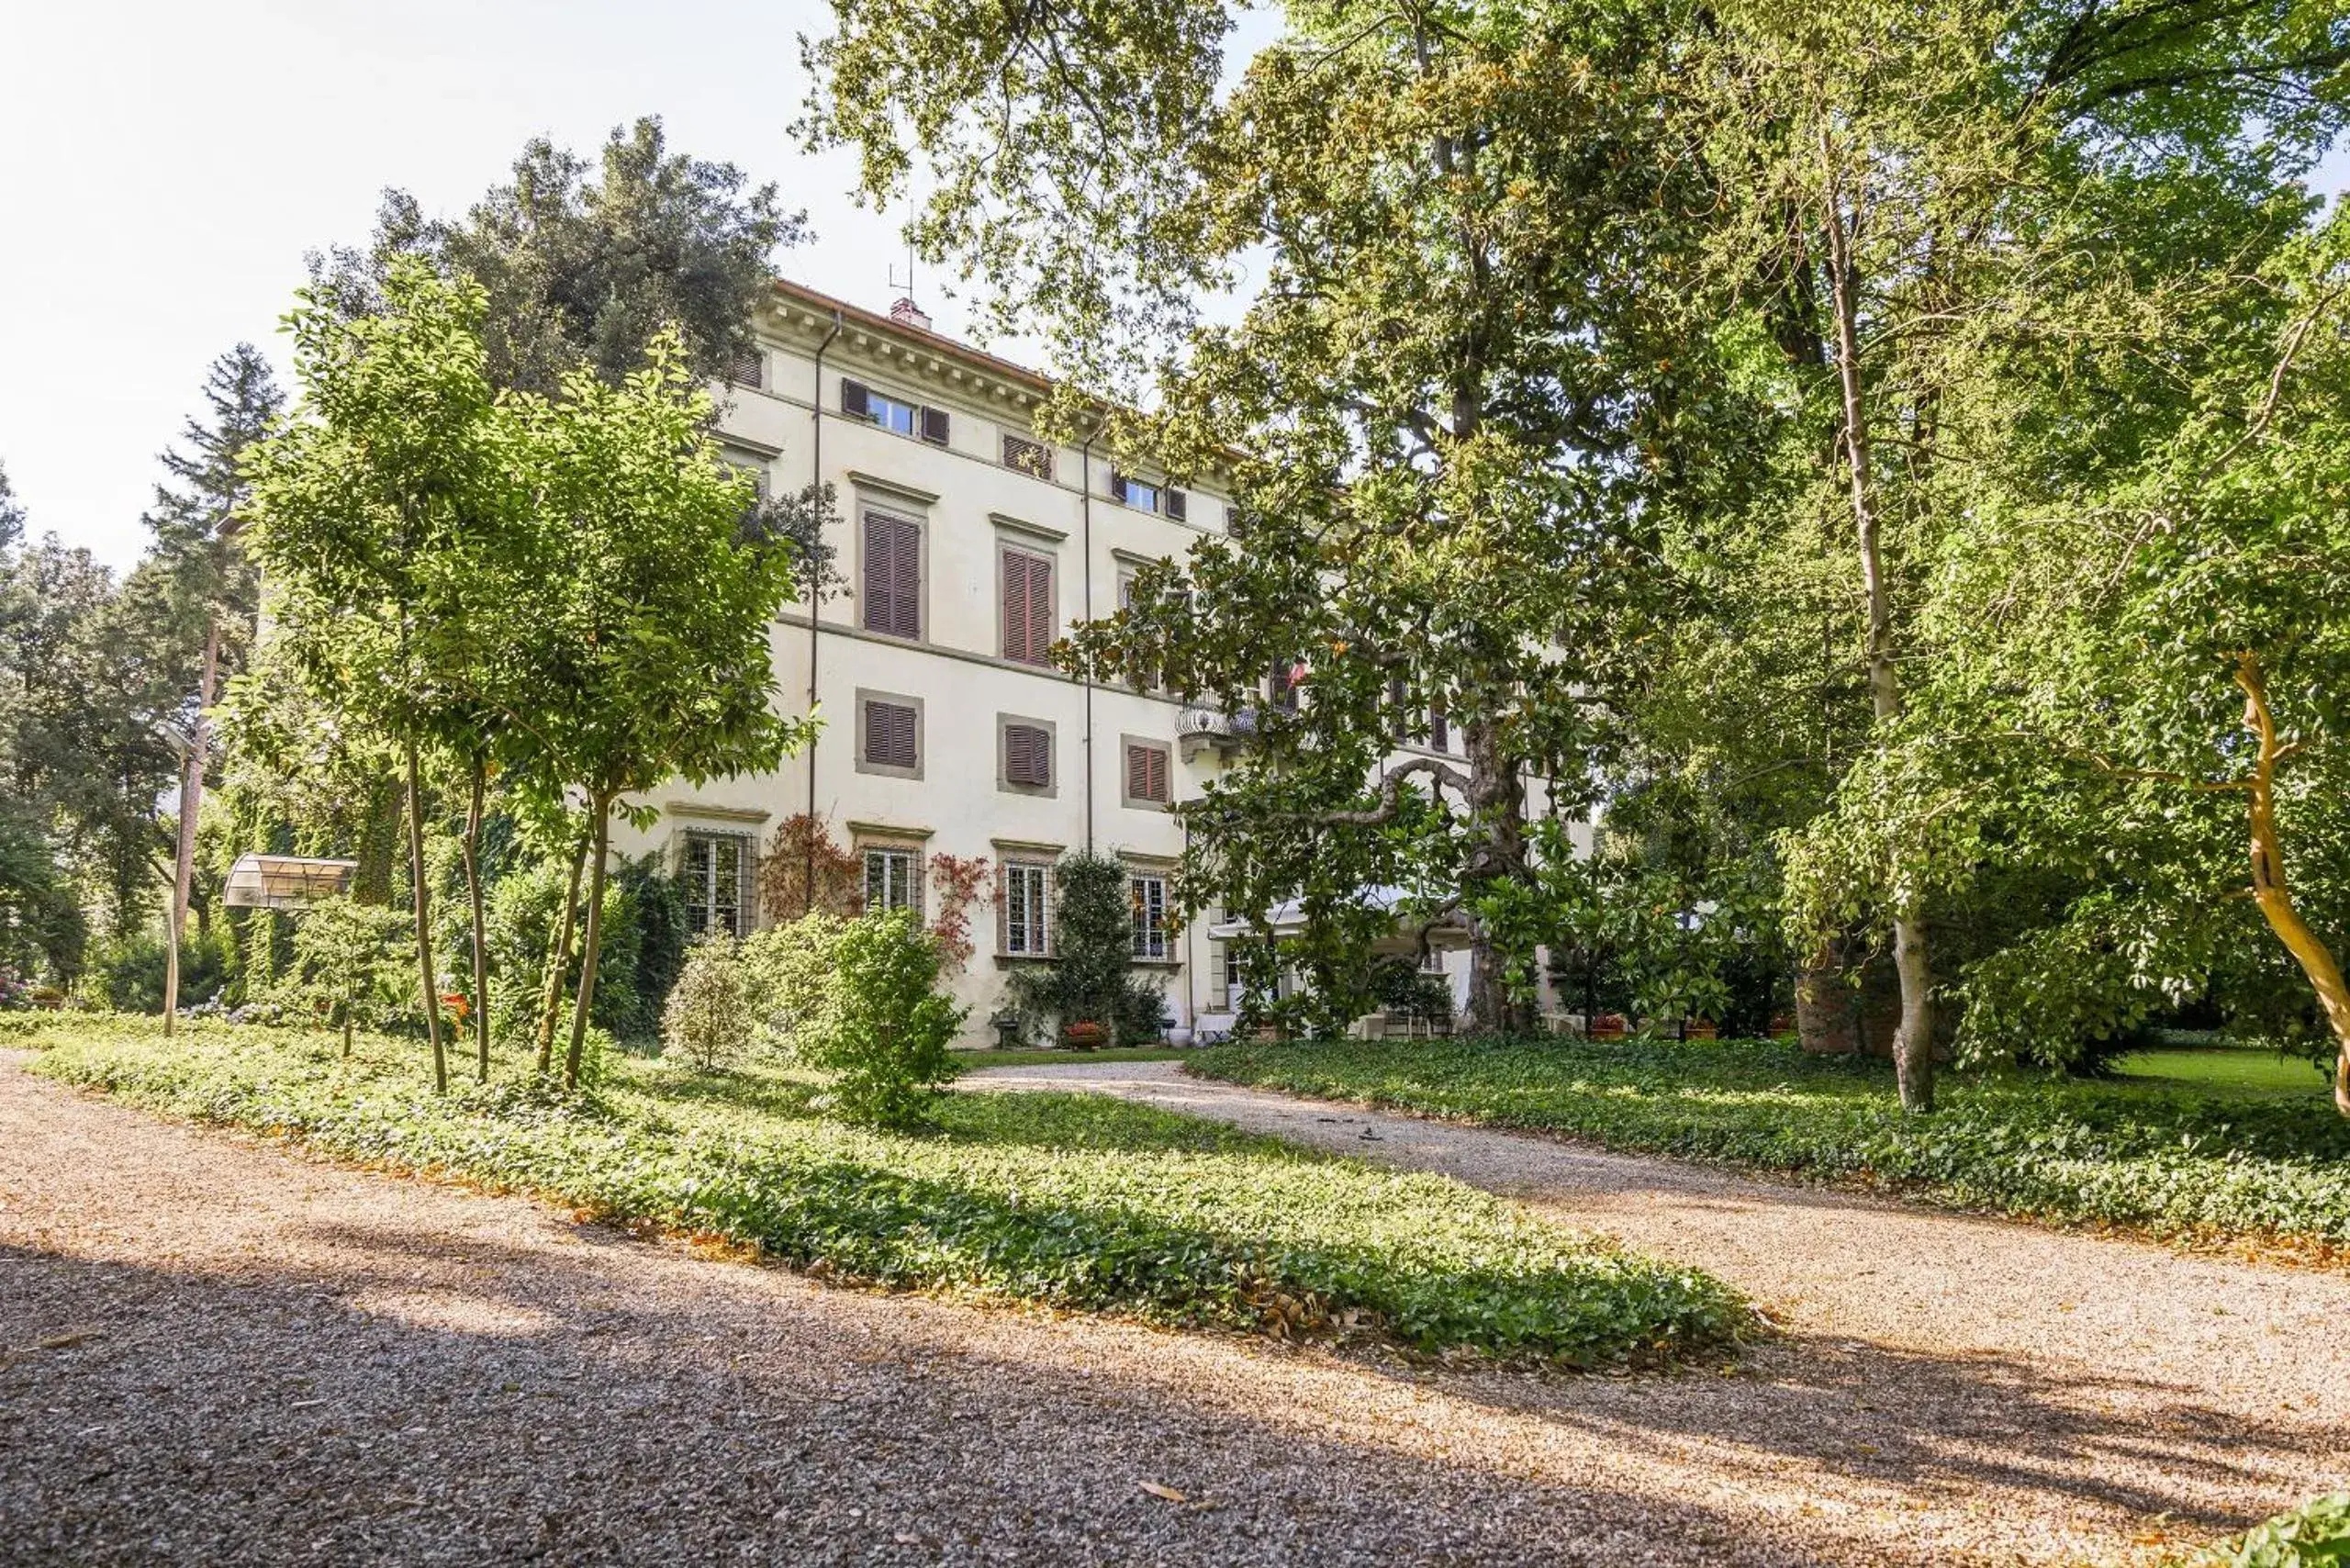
[[12, 1025, 1751, 1366]]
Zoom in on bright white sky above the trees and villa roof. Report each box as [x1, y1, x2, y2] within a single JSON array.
[[0, 0, 2350, 566]]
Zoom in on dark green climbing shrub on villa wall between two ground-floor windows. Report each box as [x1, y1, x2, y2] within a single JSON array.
[[1008, 854, 1166, 1047]]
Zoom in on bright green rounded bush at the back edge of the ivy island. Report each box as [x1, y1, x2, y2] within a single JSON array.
[[782, 910, 966, 1126]]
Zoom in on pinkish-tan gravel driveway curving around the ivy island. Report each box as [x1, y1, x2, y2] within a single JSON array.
[[0, 1053, 2350, 1568]]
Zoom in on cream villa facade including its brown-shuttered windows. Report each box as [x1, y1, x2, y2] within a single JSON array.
[[613, 282, 1460, 1044]]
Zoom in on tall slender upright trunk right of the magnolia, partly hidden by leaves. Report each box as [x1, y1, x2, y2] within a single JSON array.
[[1818, 129, 1934, 1114]]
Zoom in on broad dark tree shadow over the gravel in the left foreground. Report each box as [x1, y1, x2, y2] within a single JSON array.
[[0, 1225, 1795, 1565]]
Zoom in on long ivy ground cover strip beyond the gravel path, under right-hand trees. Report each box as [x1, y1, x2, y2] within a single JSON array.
[[1192, 1039, 2350, 1246]]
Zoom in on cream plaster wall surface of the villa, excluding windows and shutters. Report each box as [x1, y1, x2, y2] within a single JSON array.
[[613, 292, 1225, 1044]]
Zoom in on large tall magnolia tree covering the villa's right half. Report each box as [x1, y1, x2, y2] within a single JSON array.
[[815, 5, 1737, 1030]]
